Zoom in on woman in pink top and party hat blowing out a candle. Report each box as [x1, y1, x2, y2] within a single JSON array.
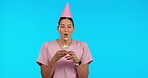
[[37, 3, 93, 78]]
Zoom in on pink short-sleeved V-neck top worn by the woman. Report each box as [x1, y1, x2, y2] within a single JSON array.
[[37, 39, 93, 78]]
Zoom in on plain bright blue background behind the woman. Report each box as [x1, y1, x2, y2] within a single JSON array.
[[0, 0, 148, 78]]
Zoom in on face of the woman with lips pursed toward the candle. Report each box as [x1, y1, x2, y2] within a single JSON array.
[[58, 19, 74, 39]]
